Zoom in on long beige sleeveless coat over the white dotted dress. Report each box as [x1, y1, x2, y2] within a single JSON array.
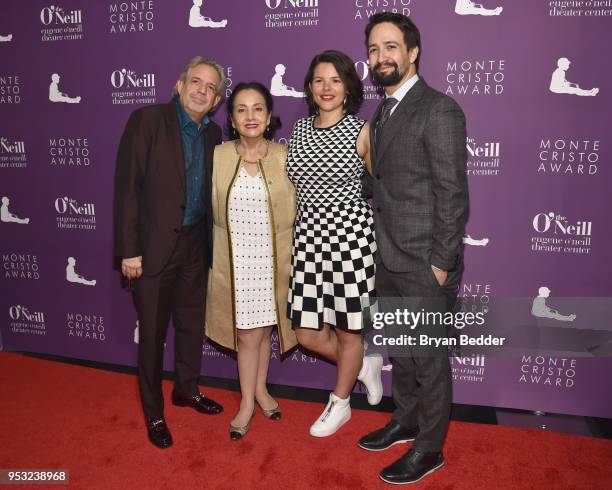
[[206, 141, 297, 353]]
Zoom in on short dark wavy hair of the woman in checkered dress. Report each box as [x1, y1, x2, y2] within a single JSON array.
[[304, 50, 363, 115]]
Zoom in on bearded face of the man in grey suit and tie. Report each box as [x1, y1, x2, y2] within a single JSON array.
[[368, 22, 419, 87]]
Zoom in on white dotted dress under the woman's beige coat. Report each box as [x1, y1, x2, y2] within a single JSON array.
[[229, 167, 276, 329]]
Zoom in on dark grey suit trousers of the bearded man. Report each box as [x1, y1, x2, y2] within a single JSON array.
[[376, 263, 461, 452]]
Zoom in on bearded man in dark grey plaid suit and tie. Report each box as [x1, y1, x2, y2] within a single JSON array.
[[359, 12, 468, 484]]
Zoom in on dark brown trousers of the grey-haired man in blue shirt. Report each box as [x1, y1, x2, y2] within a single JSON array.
[[134, 224, 208, 418]]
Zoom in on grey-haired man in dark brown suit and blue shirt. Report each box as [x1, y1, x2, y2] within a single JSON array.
[[115, 57, 226, 448]]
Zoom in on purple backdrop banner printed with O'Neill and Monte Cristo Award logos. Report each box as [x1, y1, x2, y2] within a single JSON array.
[[0, 0, 612, 417]]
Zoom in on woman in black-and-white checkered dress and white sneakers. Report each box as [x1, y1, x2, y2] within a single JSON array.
[[287, 51, 382, 437]]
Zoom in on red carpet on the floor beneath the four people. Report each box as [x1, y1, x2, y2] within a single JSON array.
[[0, 353, 612, 490]]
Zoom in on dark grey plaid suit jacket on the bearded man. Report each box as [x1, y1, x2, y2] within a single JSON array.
[[370, 78, 468, 272]]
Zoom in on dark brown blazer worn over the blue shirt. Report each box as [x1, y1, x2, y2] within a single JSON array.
[[114, 100, 221, 275]]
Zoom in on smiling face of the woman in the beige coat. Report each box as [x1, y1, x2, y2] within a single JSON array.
[[232, 89, 272, 139]]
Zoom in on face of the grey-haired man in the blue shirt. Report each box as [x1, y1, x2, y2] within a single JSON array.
[[176, 65, 221, 124]]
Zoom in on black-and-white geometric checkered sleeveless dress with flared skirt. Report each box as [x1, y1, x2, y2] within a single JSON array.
[[287, 115, 376, 330]]
